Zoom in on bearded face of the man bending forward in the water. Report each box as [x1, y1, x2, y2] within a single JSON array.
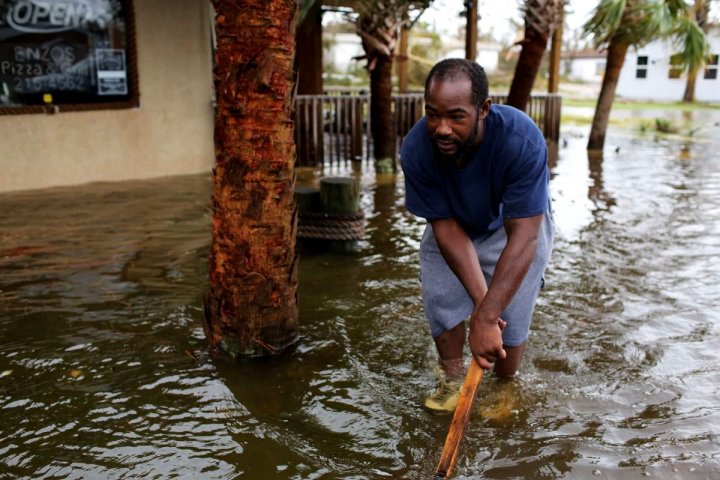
[[425, 79, 490, 166]]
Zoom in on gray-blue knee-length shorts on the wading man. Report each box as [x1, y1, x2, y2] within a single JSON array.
[[420, 213, 553, 347]]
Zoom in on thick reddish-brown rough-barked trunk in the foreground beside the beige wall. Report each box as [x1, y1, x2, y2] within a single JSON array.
[[203, 0, 298, 358]]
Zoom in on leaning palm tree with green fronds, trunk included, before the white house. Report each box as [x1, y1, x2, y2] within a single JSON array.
[[583, 0, 706, 150]]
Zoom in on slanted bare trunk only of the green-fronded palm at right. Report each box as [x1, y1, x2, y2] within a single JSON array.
[[587, 37, 629, 150]]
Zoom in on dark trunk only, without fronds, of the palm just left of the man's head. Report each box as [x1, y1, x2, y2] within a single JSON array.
[[370, 56, 396, 160]]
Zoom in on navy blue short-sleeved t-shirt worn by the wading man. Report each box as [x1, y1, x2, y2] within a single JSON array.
[[400, 105, 550, 239]]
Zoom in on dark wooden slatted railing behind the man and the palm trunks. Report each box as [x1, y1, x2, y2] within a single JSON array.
[[295, 90, 562, 166]]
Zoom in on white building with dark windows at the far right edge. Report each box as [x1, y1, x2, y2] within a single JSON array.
[[616, 29, 720, 102]]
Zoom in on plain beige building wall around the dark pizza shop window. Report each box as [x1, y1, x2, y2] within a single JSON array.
[[0, 0, 214, 192]]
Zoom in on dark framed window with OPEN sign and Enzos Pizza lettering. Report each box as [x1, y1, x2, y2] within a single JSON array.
[[0, 0, 137, 113]]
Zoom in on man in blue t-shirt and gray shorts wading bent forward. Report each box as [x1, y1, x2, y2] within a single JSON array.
[[400, 59, 553, 413]]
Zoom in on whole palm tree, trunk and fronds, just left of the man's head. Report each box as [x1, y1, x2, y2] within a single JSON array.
[[349, 0, 432, 170]]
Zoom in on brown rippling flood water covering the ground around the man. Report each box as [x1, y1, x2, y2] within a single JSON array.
[[0, 110, 720, 479]]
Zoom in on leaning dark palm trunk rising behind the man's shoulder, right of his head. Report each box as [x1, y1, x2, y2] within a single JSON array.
[[507, 0, 565, 110]]
